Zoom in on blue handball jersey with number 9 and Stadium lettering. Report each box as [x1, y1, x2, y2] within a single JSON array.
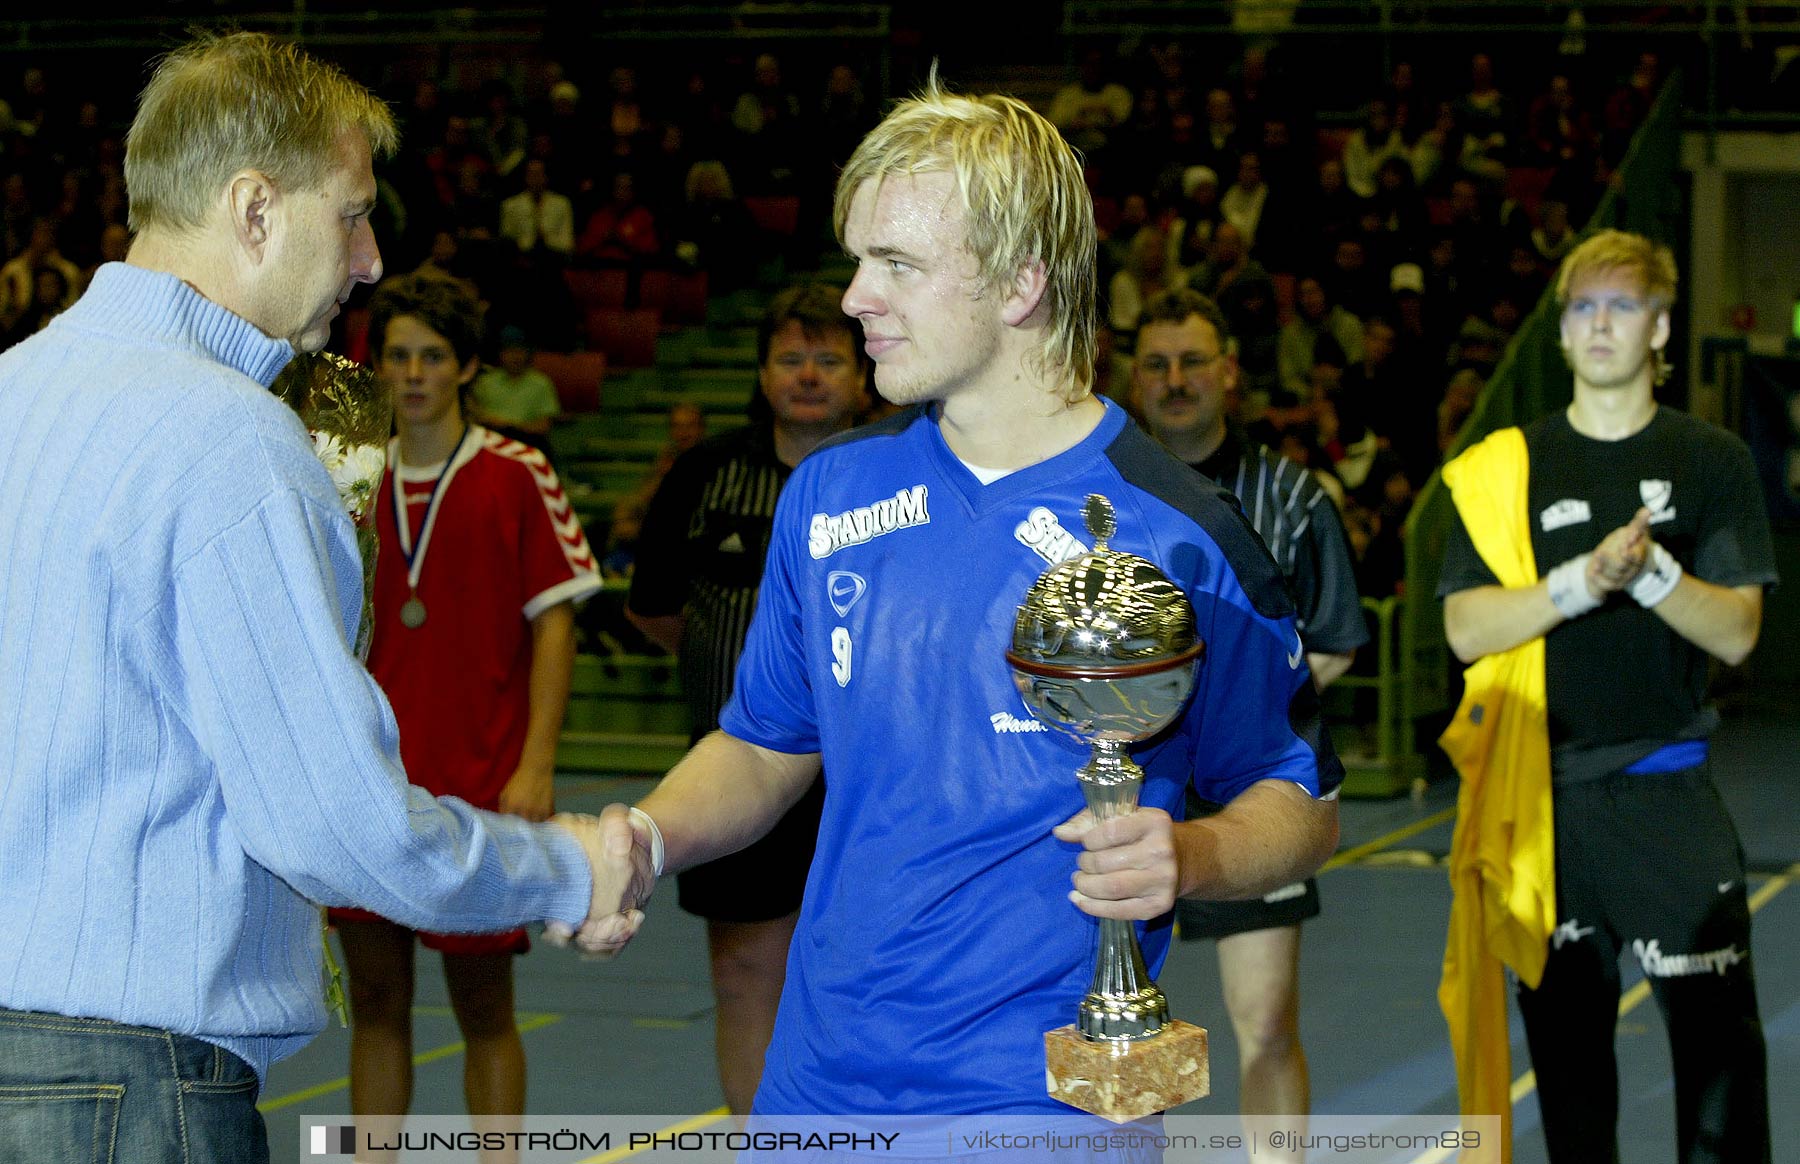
[[720, 403, 1341, 1115]]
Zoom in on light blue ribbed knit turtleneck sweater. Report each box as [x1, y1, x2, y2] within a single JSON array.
[[0, 263, 590, 1076]]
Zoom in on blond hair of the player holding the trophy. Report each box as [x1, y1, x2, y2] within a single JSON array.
[[832, 67, 1096, 399]]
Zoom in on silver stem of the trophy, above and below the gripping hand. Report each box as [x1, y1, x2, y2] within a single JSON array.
[[1075, 739, 1168, 1043]]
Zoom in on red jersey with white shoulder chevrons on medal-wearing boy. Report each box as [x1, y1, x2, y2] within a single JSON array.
[[369, 425, 601, 808]]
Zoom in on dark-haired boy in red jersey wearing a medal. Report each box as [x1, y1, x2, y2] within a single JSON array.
[[333, 277, 601, 1159]]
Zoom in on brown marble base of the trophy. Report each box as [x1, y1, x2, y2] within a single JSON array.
[[1044, 1018, 1211, 1124]]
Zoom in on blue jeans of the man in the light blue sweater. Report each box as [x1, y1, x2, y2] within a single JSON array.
[[0, 1007, 268, 1164]]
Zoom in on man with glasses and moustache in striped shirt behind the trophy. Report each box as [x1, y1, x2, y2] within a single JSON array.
[[1132, 290, 1368, 1159]]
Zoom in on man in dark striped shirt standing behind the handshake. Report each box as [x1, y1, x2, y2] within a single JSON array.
[[626, 284, 868, 1114]]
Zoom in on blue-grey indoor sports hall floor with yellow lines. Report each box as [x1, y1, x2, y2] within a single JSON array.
[[263, 693, 1800, 1164]]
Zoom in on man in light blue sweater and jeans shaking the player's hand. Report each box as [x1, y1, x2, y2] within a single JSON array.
[[0, 34, 650, 1162]]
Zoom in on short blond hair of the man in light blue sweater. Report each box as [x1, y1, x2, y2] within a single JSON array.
[[124, 32, 400, 230]]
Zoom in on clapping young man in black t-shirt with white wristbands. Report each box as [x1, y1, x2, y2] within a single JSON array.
[[1438, 230, 1777, 1164]]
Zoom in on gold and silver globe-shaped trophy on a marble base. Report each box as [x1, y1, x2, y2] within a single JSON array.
[[1006, 493, 1211, 1123]]
